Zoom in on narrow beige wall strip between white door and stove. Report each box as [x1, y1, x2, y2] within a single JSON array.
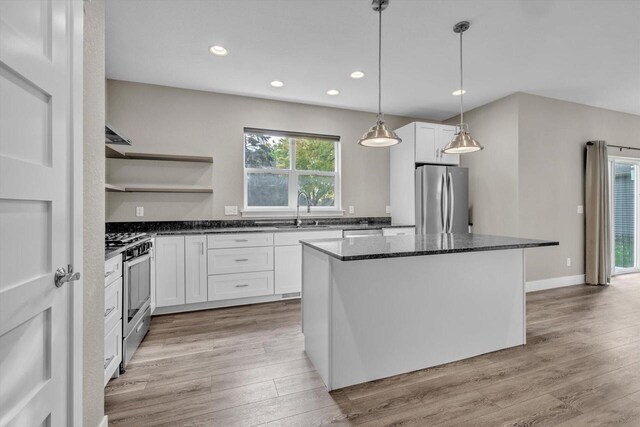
[[82, 0, 105, 427]]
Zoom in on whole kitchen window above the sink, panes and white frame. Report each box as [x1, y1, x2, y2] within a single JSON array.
[[243, 128, 341, 216]]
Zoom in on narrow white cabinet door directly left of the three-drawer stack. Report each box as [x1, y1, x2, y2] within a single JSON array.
[[184, 236, 207, 304]]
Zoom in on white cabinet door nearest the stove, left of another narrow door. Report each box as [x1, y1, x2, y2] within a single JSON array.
[[155, 236, 186, 307]]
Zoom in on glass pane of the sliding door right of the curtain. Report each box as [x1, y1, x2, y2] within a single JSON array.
[[614, 162, 636, 268]]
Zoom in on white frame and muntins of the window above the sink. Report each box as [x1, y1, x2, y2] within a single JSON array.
[[241, 128, 344, 217]]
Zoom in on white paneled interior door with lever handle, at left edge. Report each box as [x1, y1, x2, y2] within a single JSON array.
[[0, 0, 82, 426]]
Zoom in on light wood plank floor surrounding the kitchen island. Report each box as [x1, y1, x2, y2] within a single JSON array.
[[105, 275, 640, 426]]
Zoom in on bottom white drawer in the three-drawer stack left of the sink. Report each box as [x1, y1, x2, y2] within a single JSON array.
[[208, 271, 273, 301]]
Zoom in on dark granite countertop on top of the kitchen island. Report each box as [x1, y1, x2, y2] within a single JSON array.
[[301, 234, 559, 261]]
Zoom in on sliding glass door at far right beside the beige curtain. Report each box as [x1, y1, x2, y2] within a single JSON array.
[[609, 158, 640, 274]]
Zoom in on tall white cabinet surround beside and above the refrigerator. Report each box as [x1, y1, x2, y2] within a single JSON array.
[[389, 122, 460, 225]]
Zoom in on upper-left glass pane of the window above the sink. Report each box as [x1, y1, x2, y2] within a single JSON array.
[[244, 133, 291, 169]]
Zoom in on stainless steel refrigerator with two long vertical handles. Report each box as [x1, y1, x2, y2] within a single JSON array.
[[416, 165, 469, 234]]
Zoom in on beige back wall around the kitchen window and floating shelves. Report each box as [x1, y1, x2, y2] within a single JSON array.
[[107, 80, 416, 222]]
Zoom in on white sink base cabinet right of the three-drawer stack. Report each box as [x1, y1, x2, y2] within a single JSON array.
[[274, 230, 342, 294]]
